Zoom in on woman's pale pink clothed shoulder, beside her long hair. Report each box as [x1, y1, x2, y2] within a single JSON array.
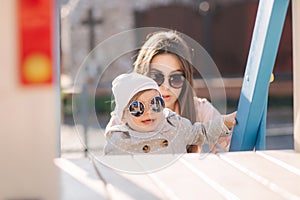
[[194, 97, 221, 122]]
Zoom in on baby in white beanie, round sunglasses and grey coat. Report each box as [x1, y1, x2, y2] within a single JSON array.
[[104, 73, 236, 155]]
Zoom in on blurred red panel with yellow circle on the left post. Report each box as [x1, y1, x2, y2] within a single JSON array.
[[18, 0, 54, 85]]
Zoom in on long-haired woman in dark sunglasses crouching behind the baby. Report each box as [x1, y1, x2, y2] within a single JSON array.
[[134, 31, 230, 152]]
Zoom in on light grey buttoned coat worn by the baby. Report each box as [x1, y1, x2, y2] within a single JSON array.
[[104, 108, 231, 155]]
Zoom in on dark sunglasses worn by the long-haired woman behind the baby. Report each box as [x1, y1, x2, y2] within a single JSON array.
[[150, 72, 185, 89]]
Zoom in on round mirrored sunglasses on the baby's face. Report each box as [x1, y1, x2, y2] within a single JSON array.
[[128, 97, 165, 117]]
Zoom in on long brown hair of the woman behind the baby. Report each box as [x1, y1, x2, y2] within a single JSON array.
[[134, 31, 196, 122]]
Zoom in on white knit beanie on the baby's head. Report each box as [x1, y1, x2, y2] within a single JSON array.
[[112, 72, 160, 121]]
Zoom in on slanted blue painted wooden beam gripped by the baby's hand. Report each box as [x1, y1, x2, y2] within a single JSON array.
[[229, 0, 289, 151]]
